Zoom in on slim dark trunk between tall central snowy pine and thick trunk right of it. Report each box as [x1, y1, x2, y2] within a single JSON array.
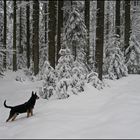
[[85, 0, 90, 64]]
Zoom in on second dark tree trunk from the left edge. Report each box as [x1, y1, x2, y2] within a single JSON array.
[[13, 0, 17, 71]]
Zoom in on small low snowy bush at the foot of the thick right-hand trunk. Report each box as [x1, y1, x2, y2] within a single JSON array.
[[87, 71, 105, 90]]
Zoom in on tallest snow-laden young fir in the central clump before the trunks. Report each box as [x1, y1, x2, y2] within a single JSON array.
[[55, 48, 74, 99]]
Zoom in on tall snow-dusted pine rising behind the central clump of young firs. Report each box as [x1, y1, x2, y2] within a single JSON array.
[[64, 2, 87, 60]]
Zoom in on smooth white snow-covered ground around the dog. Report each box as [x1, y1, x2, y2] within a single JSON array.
[[0, 72, 140, 139]]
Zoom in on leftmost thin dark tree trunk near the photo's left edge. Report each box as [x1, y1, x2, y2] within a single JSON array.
[[3, 0, 7, 69]]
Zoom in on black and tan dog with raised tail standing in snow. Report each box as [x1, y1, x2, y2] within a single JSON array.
[[4, 91, 39, 122]]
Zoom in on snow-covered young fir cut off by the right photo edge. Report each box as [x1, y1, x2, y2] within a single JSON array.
[[125, 35, 140, 74]]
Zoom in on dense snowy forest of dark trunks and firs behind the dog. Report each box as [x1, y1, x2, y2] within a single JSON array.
[[0, 0, 140, 99]]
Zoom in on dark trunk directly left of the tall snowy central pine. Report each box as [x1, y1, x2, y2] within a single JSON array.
[[57, 0, 64, 62]]
